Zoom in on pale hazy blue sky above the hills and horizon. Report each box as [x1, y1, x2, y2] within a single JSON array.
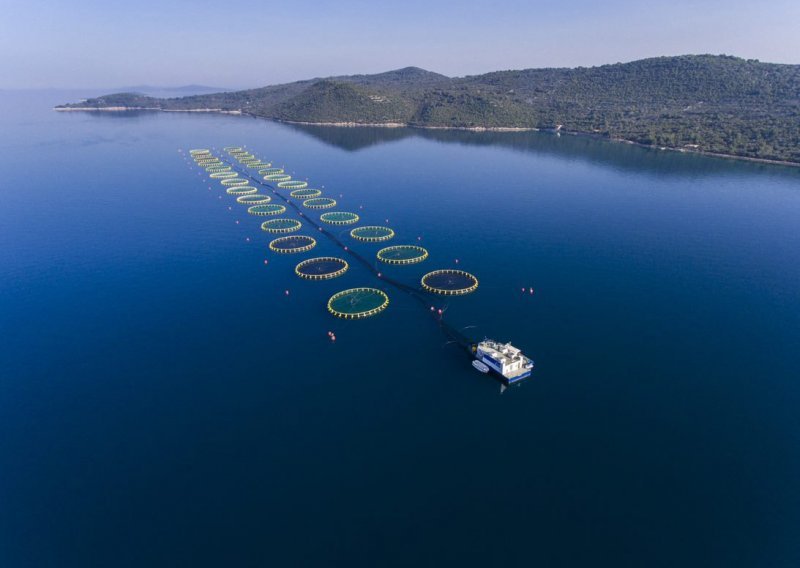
[[0, 0, 800, 88]]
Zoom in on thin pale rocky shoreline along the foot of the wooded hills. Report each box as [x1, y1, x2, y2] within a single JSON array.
[[53, 106, 800, 168]]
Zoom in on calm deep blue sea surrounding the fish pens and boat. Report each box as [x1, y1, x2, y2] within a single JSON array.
[[0, 92, 800, 568]]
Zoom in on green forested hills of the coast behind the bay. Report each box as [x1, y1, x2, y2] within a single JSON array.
[[61, 55, 800, 163]]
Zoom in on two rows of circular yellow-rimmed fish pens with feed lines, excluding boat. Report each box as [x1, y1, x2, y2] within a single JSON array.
[[189, 146, 496, 368]]
